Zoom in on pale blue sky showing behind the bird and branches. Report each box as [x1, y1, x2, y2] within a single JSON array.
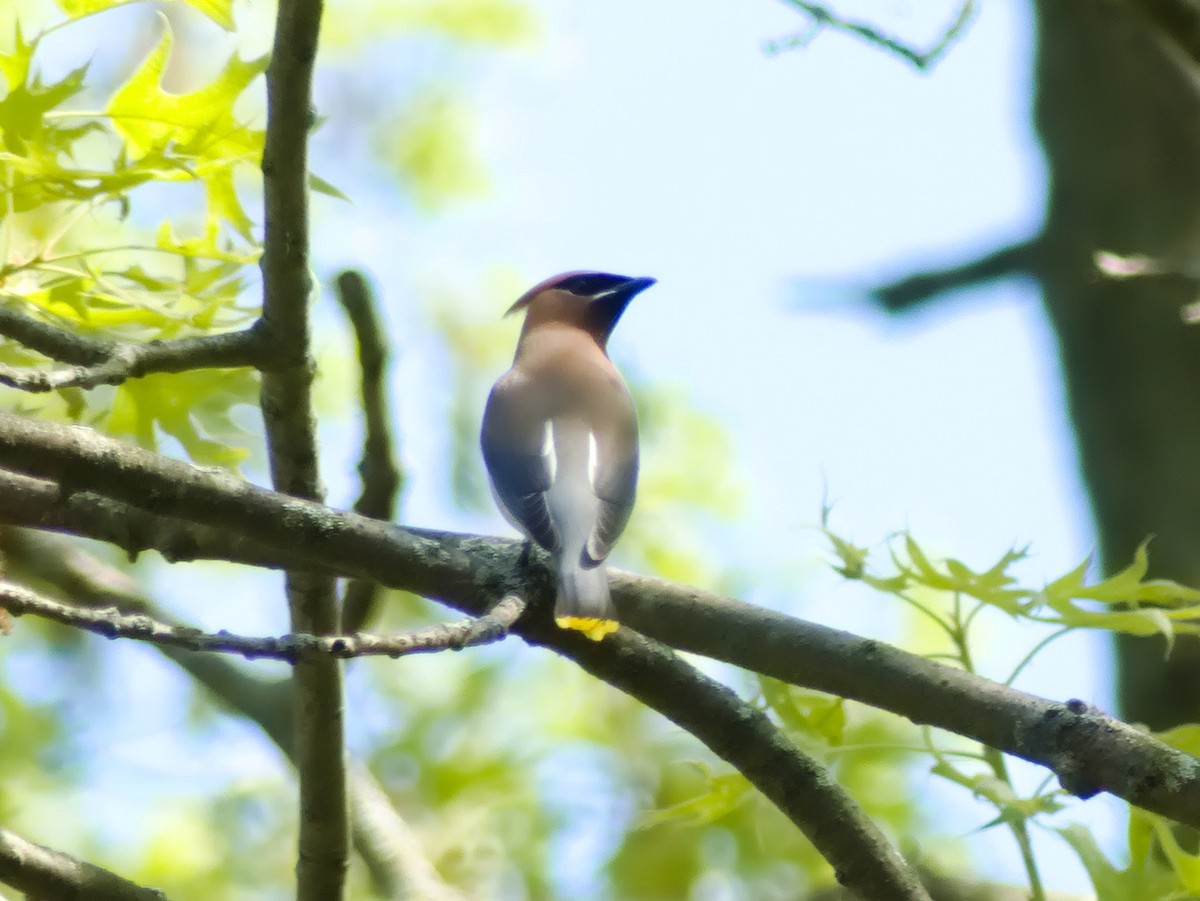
[[14, 0, 1121, 890]]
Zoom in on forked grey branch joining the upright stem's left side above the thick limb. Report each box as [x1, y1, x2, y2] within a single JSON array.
[[0, 326, 262, 392]]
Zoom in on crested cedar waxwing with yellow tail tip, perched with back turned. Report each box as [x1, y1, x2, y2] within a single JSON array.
[[481, 272, 654, 641]]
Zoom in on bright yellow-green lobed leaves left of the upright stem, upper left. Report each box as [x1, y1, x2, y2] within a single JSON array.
[[0, 0, 265, 465]]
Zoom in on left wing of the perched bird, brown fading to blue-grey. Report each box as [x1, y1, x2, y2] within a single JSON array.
[[480, 372, 559, 552]]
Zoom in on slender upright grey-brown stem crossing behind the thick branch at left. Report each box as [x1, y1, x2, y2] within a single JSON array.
[[258, 0, 349, 887]]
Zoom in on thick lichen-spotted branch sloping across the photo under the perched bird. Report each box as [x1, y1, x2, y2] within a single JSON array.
[[0, 413, 1200, 827]]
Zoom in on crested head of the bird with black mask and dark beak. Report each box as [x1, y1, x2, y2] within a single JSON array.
[[505, 272, 655, 347]]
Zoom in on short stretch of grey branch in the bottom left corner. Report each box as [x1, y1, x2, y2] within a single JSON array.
[[0, 828, 167, 901]]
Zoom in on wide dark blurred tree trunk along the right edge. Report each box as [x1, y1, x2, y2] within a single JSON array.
[[1036, 0, 1200, 729]]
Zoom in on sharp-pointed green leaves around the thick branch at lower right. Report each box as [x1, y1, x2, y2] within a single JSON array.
[[823, 525, 1200, 901]]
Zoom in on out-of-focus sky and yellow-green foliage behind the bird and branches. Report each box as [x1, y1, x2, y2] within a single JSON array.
[[7, 0, 1190, 901]]
